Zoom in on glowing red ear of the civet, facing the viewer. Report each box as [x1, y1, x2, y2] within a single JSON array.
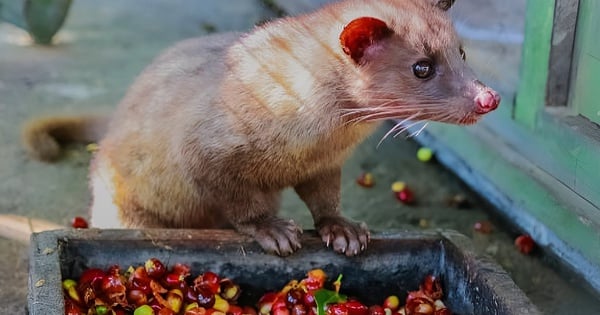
[[340, 17, 392, 63]]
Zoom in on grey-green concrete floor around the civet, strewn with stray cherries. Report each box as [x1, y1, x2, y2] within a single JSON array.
[[0, 0, 600, 314]]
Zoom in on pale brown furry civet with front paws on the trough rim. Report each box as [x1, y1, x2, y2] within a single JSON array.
[[25, 0, 499, 255]]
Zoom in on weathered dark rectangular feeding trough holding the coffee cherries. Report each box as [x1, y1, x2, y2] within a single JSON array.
[[28, 229, 541, 315]]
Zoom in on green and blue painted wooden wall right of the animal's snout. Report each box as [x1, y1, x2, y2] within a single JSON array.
[[417, 0, 600, 290]]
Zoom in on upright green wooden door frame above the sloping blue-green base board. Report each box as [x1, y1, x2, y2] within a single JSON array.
[[512, 0, 600, 209]]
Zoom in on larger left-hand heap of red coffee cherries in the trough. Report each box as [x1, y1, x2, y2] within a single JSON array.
[[62, 258, 244, 315]]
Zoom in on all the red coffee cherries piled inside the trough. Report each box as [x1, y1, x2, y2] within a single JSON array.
[[62, 258, 451, 315]]
